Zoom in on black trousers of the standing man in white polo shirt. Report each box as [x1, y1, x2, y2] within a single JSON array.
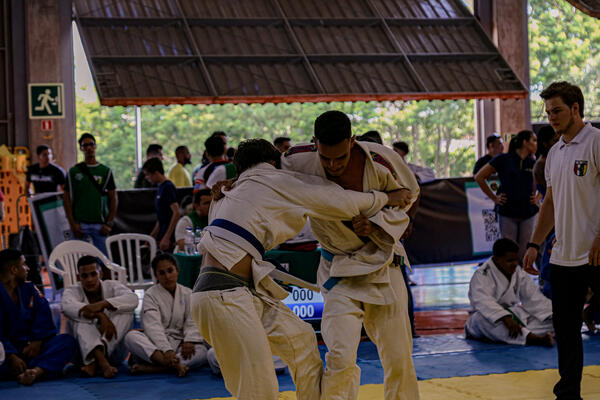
[[550, 264, 600, 400]]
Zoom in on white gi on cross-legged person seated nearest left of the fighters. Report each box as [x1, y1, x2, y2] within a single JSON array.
[[125, 284, 207, 368]]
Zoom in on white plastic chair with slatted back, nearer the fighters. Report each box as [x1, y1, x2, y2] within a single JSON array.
[[106, 233, 156, 290]]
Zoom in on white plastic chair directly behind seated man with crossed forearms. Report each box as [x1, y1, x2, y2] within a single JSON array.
[[48, 240, 127, 287]]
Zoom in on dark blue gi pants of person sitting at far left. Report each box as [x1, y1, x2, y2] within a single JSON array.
[[0, 334, 76, 378]]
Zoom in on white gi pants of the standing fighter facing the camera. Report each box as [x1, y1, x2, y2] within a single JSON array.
[[321, 267, 419, 400]]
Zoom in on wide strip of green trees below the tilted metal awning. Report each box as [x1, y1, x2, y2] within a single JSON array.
[[77, 97, 475, 188]]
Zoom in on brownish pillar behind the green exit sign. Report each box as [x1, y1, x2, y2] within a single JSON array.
[[25, 0, 77, 169]]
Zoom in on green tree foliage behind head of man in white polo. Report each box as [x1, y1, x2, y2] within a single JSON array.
[[529, 0, 600, 121]]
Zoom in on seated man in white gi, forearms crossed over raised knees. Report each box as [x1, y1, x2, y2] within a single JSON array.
[[62, 256, 138, 378]]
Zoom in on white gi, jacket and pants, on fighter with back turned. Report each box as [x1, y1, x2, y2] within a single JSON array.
[[192, 163, 388, 400]]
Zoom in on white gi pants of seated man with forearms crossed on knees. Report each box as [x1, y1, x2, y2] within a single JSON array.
[[67, 311, 133, 365]]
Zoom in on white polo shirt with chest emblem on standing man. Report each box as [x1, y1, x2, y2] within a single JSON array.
[[545, 123, 600, 266]]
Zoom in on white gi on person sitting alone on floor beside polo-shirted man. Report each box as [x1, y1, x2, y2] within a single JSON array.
[[465, 258, 553, 345]]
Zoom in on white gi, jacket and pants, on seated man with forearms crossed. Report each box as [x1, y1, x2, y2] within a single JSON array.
[[61, 280, 138, 365]]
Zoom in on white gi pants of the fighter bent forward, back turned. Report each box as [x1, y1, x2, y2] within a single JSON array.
[[192, 287, 323, 400]]
